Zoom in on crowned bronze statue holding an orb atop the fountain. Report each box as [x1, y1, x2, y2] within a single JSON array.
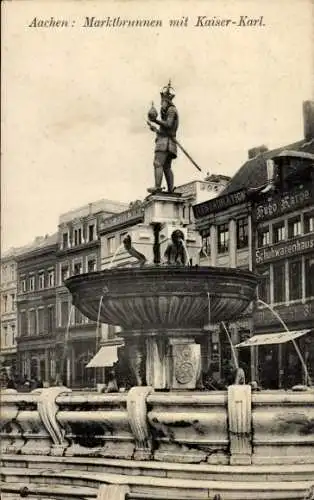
[[147, 82, 179, 193]]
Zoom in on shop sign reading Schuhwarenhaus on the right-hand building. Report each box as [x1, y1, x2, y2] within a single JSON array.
[[255, 233, 314, 264]]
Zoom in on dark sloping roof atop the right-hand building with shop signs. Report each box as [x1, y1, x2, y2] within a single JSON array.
[[220, 139, 314, 196]]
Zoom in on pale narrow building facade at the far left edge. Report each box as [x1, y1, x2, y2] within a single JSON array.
[[1, 249, 18, 375]]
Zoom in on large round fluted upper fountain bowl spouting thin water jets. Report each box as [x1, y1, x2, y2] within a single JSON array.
[[65, 266, 257, 331]]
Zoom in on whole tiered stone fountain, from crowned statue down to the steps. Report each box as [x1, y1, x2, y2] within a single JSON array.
[[1, 85, 314, 500]]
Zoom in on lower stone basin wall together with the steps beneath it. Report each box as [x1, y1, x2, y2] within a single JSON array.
[[0, 385, 314, 500]]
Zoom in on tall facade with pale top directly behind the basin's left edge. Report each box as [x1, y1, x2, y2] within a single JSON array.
[[56, 200, 128, 387]]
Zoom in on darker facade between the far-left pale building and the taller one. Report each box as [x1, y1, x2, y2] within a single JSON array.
[[16, 234, 57, 383]]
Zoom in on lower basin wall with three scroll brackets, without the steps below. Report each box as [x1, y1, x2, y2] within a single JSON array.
[[1, 385, 314, 465]]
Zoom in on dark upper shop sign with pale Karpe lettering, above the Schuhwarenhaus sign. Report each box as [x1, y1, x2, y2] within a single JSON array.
[[254, 185, 314, 222]]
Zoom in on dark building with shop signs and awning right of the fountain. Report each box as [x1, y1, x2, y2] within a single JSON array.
[[194, 102, 314, 388]]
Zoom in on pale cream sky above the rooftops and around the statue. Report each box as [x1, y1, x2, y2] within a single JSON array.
[[1, 0, 313, 250]]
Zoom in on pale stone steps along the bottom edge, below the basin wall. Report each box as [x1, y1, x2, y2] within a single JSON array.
[[2, 467, 313, 500]]
